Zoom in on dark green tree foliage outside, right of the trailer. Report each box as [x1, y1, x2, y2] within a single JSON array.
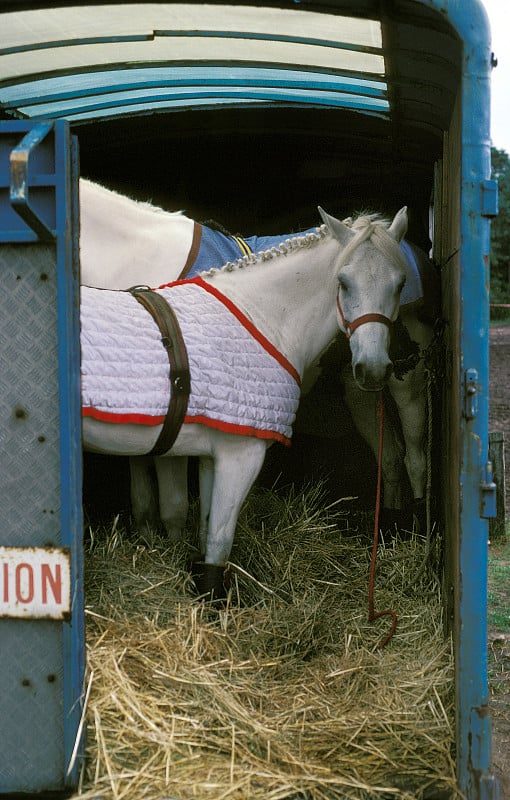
[[490, 147, 510, 319]]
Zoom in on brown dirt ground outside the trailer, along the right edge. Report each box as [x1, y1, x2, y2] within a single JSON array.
[[489, 325, 510, 800]]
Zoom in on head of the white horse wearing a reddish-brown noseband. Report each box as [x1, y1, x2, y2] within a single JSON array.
[[319, 207, 407, 391]]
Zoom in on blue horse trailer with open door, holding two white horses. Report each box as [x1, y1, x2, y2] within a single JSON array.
[[0, 0, 498, 800]]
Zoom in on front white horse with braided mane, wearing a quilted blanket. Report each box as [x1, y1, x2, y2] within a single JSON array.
[[82, 208, 407, 594]]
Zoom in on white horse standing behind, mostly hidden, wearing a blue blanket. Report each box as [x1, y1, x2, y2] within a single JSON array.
[[80, 179, 431, 538]]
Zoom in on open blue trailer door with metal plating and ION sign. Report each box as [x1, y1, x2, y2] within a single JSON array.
[[0, 121, 84, 793]]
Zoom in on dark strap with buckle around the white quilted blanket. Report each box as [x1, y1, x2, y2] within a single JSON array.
[[128, 286, 190, 456]]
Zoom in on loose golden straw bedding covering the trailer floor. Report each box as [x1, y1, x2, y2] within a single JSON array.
[[75, 487, 456, 800]]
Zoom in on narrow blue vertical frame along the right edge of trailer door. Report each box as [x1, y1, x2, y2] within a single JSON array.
[[54, 120, 85, 788]]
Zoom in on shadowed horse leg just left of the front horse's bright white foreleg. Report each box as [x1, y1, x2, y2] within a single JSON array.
[[154, 456, 188, 542]]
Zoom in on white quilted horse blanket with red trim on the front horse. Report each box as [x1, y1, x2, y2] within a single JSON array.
[[81, 278, 300, 444]]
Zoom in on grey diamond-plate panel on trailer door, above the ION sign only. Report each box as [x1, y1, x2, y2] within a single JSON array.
[[0, 245, 61, 546]]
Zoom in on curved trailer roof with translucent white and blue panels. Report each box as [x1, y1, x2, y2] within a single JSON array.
[[0, 0, 460, 133]]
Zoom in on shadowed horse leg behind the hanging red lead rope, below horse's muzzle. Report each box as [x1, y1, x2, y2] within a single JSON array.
[[342, 364, 404, 509]]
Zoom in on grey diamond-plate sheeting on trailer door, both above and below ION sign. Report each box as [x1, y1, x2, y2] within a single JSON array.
[[0, 244, 68, 792]]
